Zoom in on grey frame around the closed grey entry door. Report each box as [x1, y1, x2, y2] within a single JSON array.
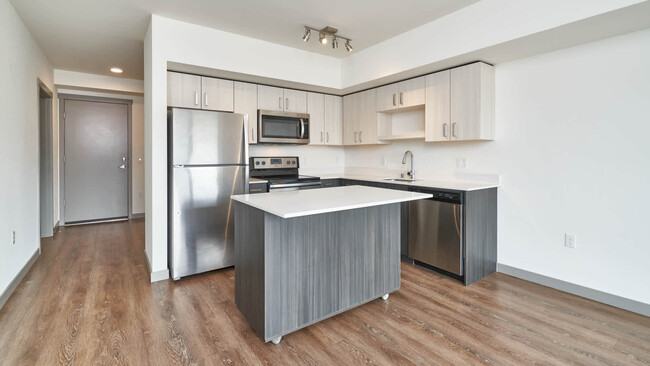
[[58, 94, 133, 226]]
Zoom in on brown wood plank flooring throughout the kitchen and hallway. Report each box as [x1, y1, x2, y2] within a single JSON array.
[[0, 220, 650, 365]]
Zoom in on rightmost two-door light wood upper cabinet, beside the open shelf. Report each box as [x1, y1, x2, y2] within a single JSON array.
[[425, 62, 494, 141]]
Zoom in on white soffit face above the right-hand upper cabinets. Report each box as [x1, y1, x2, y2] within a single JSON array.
[[341, 0, 642, 89]]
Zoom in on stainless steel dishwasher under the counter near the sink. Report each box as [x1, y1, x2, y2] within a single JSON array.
[[408, 188, 463, 276]]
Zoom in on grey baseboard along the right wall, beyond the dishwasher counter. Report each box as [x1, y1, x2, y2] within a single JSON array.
[[497, 263, 650, 316]]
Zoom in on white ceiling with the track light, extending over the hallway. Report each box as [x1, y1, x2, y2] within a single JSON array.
[[11, 0, 478, 79]]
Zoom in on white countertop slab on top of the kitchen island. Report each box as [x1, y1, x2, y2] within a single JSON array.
[[232, 186, 432, 219]]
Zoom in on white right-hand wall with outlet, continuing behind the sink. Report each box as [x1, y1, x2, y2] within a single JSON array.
[[345, 30, 650, 303]]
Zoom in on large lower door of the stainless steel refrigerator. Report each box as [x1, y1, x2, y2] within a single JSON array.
[[169, 166, 248, 278]]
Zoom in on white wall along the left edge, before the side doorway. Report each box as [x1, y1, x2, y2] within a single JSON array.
[[0, 0, 56, 293]]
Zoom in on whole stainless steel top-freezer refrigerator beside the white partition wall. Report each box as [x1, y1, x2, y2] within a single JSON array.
[[167, 108, 248, 280]]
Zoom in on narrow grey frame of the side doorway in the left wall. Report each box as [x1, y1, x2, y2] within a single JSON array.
[[36, 78, 55, 242]]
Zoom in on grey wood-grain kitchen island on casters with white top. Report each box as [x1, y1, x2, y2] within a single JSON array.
[[232, 186, 431, 343]]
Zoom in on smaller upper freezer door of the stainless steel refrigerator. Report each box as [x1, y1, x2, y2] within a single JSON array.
[[169, 108, 248, 165]]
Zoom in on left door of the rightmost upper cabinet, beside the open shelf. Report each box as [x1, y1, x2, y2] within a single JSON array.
[[424, 70, 451, 141]]
